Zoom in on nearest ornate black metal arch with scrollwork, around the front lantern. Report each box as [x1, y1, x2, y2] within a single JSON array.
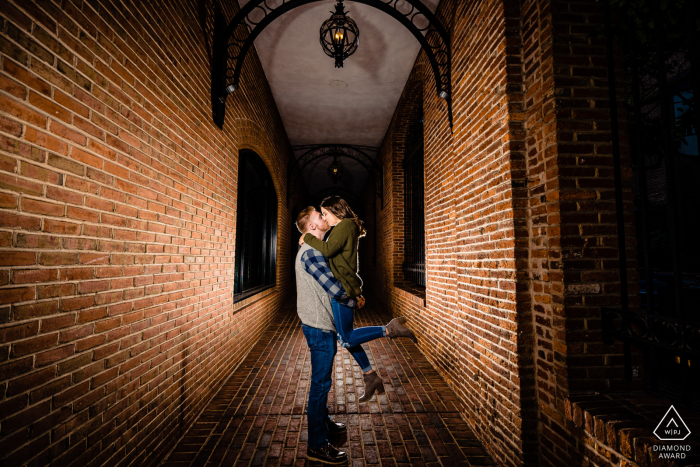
[[212, 0, 452, 128]]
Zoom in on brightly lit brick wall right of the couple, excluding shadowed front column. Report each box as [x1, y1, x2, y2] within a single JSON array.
[[366, 1, 536, 465]]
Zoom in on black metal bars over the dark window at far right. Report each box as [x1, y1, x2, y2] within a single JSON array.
[[602, 0, 700, 410]]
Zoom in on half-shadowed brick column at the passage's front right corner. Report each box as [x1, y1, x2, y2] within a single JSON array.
[[521, 0, 636, 466]]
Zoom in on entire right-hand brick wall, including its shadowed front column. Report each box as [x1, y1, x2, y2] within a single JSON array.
[[363, 0, 636, 466]]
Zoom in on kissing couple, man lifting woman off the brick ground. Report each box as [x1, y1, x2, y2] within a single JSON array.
[[295, 196, 416, 464]]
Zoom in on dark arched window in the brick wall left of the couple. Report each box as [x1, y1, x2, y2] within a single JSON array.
[[233, 151, 277, 302]]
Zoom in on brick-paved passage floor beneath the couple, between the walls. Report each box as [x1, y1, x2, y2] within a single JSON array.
[[162, 309, 494, 467]]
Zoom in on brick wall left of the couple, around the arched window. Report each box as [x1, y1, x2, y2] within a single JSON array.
[[0, 0, 298, 466]]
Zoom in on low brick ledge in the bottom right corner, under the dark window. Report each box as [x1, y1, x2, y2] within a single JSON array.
[[565, 392, 700, 467]]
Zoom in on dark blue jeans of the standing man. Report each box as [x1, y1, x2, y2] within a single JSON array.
[[301, 324, 337, 449]]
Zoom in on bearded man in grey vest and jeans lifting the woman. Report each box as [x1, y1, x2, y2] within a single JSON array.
[[295, 206, 364, 464]]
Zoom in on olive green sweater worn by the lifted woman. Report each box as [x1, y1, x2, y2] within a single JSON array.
[[304, 219, 362, 298]]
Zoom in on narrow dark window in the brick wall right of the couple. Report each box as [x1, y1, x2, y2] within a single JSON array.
[[403, 103, 425, 287]]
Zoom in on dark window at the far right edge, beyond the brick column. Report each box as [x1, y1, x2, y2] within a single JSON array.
[[631, 76, 700, 410]]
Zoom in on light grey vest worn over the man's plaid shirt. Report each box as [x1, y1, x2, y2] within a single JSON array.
[[294, 243, 335, 332]]
